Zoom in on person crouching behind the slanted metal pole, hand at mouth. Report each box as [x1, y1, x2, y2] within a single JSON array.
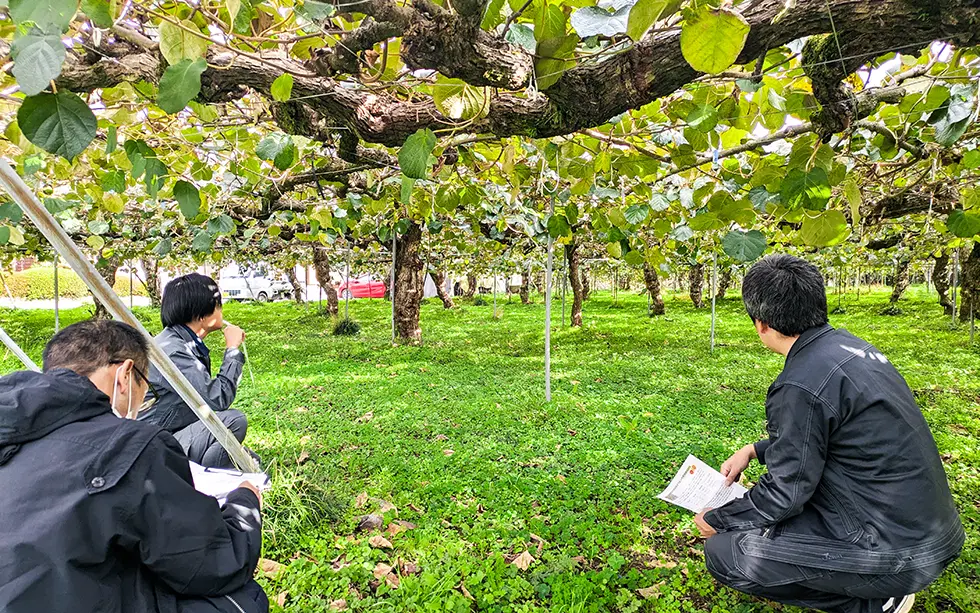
[[140, 273, 256, 468]]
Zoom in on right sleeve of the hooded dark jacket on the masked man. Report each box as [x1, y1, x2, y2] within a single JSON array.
[[126, 433, 262, 596]]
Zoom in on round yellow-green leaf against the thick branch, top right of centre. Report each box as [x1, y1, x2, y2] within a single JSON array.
[[681, 9, 749, 74]]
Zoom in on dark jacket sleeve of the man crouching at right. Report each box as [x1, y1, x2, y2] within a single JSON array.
[[705, 384, 831, 532]]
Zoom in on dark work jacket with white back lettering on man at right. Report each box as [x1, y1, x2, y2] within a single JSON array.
[[705, 325, 965, 574]]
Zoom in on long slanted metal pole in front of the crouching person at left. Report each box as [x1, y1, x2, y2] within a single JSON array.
[[0, 159, 259, 472]]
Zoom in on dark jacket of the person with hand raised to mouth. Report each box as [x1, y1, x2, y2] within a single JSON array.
[[139, 326, 245, 432]]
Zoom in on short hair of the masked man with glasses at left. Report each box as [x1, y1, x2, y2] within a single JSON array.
[[43, 319, 150, 377]]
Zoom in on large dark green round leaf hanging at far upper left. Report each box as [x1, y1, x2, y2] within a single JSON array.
[[17, 90, 98, 161]]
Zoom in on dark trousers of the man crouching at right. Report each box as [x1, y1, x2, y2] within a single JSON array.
[[704, 530, 946, 613]]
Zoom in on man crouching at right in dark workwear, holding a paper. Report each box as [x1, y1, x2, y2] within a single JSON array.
[[695, 255, 965, 613]]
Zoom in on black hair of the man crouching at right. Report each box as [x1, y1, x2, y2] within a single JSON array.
[[742, 254, 827, 336]]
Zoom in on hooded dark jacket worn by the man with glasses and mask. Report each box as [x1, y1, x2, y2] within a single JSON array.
[[0, 369, 262, 613]]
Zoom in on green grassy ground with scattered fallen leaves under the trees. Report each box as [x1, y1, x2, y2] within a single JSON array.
[[0, 288, 980, 613]]
